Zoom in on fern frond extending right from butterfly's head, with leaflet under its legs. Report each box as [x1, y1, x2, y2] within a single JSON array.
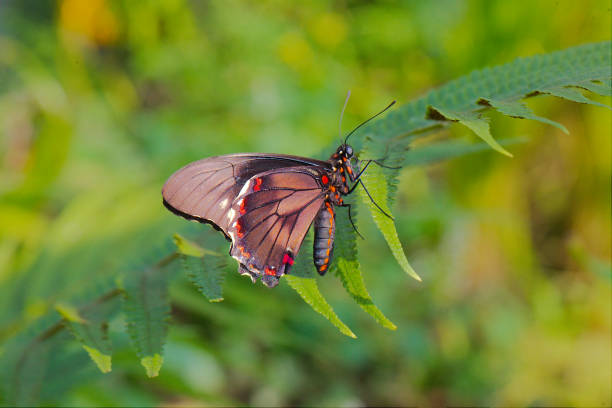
[[354, 42, 612, 284]]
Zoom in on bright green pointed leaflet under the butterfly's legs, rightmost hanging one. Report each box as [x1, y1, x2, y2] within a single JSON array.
[[357, 155, 421, 282]]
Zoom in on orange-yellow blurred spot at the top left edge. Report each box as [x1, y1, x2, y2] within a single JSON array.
[[60, 0, 119, 45]]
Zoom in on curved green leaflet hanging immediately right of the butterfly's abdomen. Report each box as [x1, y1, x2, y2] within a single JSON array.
[[332, 206, 397, 330]]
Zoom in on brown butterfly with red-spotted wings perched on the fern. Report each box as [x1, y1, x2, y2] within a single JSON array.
[[162, 93, 395, 287]]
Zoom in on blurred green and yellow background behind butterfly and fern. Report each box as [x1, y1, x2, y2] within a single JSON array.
[[0, 0, 612, 406]]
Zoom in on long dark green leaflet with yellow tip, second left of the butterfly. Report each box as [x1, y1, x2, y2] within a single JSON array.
[[123, 258, 170, 376]]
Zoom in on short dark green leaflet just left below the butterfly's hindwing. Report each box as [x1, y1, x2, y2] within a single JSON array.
[[181, 255, 227, 302]]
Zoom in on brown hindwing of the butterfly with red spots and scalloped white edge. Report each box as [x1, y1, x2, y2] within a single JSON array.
[[228, 166, 325, 287]]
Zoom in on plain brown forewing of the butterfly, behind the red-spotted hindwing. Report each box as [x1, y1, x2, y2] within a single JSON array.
[[162, 153, 329, 237]]
